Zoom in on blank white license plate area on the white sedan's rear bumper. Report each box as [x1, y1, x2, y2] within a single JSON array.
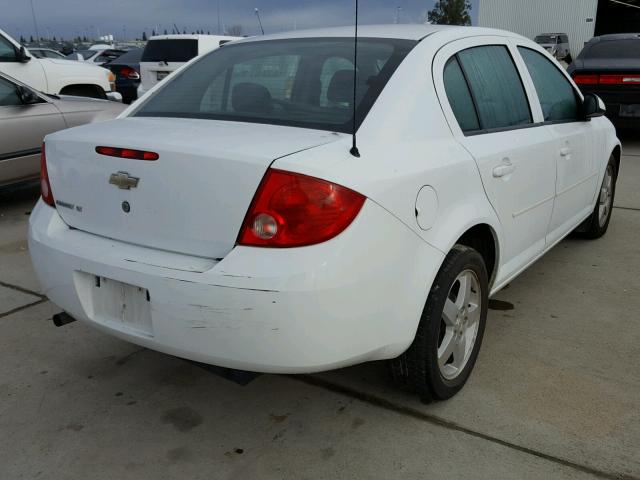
[[91, 276, 153, 336]]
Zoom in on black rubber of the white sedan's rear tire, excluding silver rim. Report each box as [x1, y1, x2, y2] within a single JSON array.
[[389, 245, 489, 403]]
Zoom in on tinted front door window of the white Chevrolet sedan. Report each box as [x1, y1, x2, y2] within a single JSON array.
[[518, 47, 579, 122]]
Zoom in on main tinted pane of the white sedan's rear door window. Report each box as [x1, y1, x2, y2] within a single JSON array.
[[458, 45, 533, 129]]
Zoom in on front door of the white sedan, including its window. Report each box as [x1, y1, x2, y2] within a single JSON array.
[[518, 45, 603, 243]]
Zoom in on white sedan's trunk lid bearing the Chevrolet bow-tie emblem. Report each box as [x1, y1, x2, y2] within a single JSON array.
[[46, 118, 342, 258]]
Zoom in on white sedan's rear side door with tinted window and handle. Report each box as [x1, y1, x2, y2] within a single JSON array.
[[434, 36, 556, 283]]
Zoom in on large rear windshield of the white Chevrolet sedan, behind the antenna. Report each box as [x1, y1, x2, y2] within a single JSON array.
[[135, 38, 416, 133]]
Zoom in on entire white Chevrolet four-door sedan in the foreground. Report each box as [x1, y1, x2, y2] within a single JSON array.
[[29, 25, 620, 400]]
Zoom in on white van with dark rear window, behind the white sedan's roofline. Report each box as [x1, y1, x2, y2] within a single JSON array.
[[138, 35, 241, 98]]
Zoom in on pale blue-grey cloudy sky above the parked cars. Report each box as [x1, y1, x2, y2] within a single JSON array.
[[0, 0, 479, 39]]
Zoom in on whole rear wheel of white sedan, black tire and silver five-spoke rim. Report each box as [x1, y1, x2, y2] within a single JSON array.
[[389, 245, 489, 402]]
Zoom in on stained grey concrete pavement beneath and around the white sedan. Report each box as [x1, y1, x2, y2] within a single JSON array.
[[0, 136, 640, 480]]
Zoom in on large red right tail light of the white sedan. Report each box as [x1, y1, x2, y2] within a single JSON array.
[[238, 169, 365, 248]]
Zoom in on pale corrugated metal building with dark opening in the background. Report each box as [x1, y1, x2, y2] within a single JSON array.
[[478, 0, 640, 58]]
